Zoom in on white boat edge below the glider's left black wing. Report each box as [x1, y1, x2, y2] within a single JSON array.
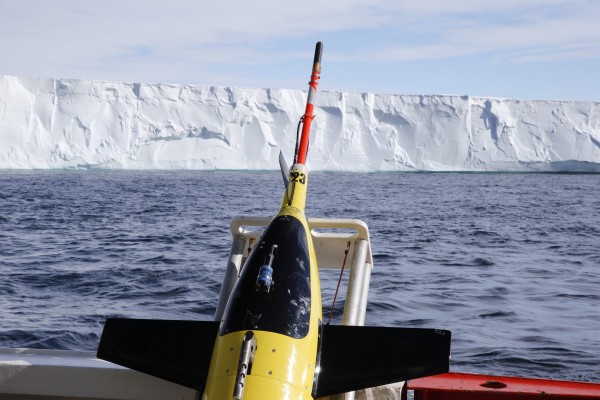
[[0, 348, 196, 400]]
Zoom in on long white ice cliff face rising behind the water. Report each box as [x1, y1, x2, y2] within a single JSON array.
[[0, 76, 600, 171]]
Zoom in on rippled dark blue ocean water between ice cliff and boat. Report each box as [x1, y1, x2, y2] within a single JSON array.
[[0, 171, 600, 381]]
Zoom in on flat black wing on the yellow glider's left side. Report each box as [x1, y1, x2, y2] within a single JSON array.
[[98, 318, 219, 391]]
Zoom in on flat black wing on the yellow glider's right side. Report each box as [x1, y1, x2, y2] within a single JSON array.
[[313, 325, 451, 398]]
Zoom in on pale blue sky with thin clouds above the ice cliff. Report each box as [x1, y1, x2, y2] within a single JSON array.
[[0, 0, 600, 101]]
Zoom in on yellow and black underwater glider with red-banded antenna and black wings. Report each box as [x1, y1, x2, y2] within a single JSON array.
[[98, 42, 451, 400]]
